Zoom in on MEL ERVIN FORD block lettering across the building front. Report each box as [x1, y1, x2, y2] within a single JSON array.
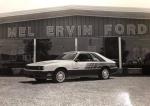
[[7, 24, 149, 38]]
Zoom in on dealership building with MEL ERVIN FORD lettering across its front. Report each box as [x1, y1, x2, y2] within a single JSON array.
[[0, 6, 150, 71]]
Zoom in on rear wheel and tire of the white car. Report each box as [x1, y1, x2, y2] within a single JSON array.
[[98, 68, 110, 80]]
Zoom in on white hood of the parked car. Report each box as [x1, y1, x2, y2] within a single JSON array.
[[28, 60, 73, 66]]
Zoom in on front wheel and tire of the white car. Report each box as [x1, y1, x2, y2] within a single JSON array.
[[52, 69, 66, 83]]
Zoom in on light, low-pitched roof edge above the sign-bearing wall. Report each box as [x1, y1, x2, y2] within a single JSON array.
[[0, 5, 150, 24]]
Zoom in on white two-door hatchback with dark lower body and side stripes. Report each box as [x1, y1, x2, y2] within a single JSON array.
[[25, 51, 117, 83]]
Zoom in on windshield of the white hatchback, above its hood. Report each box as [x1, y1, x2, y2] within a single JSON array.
[[56, 53, 76, 60]]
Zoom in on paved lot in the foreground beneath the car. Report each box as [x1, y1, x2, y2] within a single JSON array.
[[0, 76, 150, 106]]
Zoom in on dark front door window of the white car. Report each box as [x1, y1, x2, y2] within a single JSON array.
[[77, 53, 93, 61]]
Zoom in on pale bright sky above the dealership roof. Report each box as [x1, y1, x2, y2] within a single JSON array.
[[0, 0, 150, 13]]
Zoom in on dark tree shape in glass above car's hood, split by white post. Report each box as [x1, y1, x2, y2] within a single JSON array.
[[24, 39, 52, 61]]
